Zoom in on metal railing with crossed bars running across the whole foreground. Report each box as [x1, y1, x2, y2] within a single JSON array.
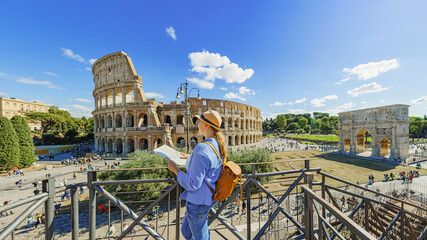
[[0, 159, 427, 240]]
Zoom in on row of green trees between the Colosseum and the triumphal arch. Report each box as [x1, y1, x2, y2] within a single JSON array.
[[262, 112, 338, 134]]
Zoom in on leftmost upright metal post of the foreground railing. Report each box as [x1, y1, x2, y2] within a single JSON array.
[[42, 178, 55, 240]]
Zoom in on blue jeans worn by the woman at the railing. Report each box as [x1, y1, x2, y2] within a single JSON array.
[[181, 201, 218, 240]]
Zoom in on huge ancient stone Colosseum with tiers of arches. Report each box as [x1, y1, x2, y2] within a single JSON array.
[[92, 52, 262, 153]]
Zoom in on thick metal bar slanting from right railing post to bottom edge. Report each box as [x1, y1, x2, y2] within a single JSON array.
[[302, 186, 375, 240]]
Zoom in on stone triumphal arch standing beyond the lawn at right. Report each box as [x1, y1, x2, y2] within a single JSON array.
[[338, 104, 409, 160]]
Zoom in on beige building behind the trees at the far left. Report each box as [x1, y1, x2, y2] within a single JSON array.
[[0, 97, 49, 130]]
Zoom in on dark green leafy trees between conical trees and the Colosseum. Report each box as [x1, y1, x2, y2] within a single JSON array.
[[25, 106, 94, 145]]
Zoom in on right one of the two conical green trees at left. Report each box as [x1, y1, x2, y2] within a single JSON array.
[[10, 115, 36, 167]]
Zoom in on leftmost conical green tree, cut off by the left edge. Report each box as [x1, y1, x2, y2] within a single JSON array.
[[0, 117, 20, 171]]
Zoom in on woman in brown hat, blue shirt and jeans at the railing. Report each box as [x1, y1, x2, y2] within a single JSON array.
[[168, 110, 227, 240]]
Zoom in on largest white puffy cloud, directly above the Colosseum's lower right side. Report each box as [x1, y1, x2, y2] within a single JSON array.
[[188, 51, 254, 89]]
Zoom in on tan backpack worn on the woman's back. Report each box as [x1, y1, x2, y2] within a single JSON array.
[[203, 142, 242, 202]]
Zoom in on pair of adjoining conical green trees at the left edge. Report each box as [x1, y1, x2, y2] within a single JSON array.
[[0, 115, 36, 171]]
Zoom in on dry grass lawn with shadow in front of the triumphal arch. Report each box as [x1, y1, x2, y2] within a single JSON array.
[[272, 150, 427, 187]]
